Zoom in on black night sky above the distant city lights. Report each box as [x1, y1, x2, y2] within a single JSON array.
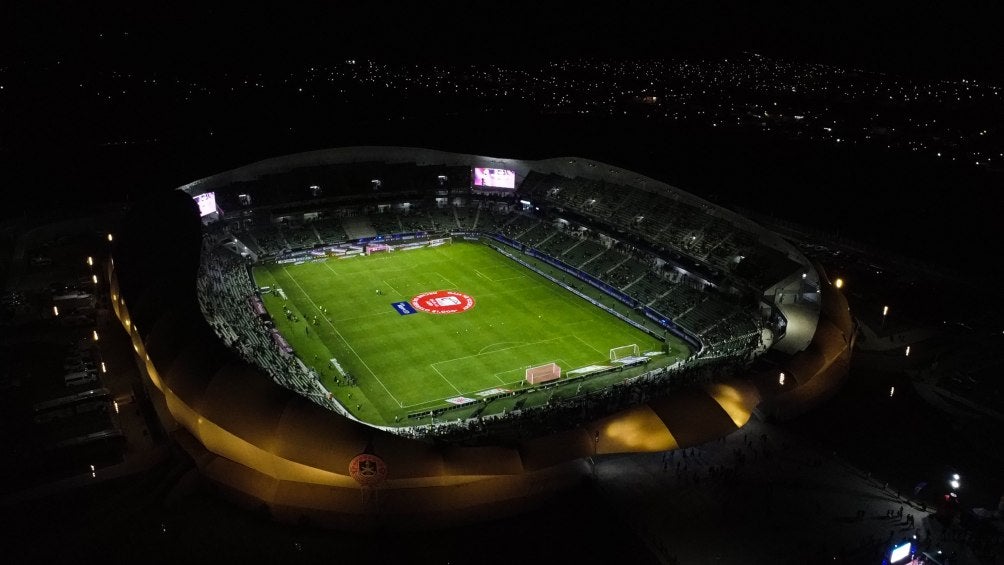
[[7, 1, 1004, 77]]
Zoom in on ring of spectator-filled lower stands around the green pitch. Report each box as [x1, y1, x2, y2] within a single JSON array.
[[198, 192, 775, 437]]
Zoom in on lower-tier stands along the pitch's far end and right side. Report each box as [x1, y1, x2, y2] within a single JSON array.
[[221, 196, 761, 361]]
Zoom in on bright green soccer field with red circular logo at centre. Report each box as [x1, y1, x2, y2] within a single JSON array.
[[254, 243, 688, 426]]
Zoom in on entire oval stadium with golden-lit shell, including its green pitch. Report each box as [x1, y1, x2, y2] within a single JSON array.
[[108, 147, 854, 530]]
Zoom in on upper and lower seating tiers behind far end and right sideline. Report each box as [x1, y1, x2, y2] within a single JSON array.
[[211, 172, 763, 371]]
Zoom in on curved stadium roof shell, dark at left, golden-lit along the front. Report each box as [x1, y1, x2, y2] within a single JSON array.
[[109, 148, 849, 528]]
